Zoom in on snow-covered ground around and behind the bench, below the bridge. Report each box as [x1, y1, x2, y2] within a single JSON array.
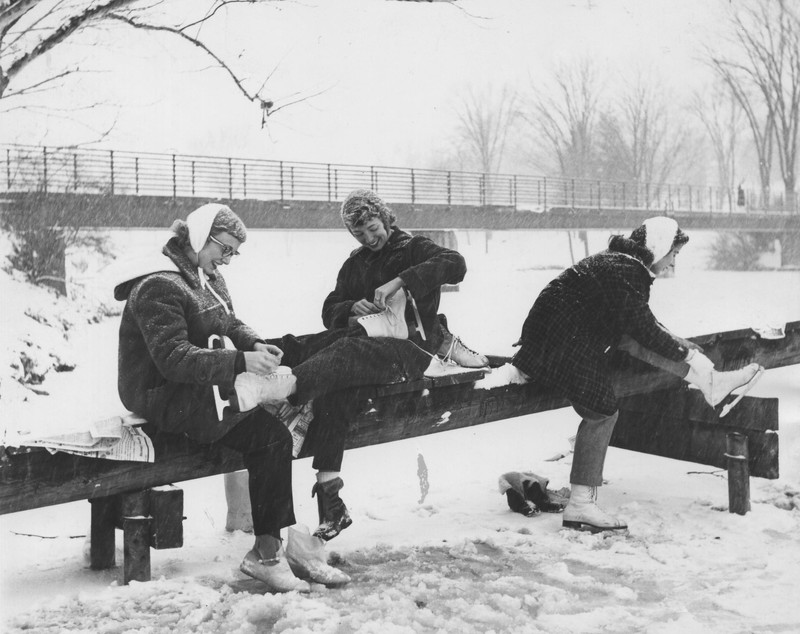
[[0, 231, 800, 634]]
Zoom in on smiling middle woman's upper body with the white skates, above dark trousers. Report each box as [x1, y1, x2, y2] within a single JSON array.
[[322, 189, 489, 367]]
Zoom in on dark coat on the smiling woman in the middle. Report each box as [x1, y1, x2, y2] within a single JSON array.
[[322, 227, 467, 350]]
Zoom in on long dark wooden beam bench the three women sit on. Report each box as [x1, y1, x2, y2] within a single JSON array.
[[0, 321, 800, 583]]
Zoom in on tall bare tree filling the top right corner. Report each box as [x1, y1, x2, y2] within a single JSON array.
[[709, 0, 800, 209]]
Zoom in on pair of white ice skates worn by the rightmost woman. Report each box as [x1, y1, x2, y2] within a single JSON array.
[[561, 351, 764, 533]]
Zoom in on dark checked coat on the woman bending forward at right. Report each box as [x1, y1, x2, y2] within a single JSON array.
[[513, 250, 687, 415]]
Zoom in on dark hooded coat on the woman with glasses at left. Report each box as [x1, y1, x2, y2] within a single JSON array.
[[114, 238, 261, 442]]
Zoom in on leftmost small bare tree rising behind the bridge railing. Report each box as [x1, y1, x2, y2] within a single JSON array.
[[457, 86, 519, 174]]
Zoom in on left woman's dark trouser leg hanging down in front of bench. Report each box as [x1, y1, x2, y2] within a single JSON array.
[[217, 407, 295, 538]]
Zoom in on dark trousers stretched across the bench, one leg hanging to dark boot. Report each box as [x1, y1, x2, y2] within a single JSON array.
[[268, 326, 430, 471]]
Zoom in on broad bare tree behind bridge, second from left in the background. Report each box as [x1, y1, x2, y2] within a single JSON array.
[[525, 59, 601, 178]]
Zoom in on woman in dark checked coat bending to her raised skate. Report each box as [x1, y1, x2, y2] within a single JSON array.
[[505, 216, 760, 531]]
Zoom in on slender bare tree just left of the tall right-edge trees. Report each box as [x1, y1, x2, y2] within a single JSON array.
[[689, 84, 744, 211]]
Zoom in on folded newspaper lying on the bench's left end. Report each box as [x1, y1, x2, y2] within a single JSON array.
[[14, 414, 155, 462]]
